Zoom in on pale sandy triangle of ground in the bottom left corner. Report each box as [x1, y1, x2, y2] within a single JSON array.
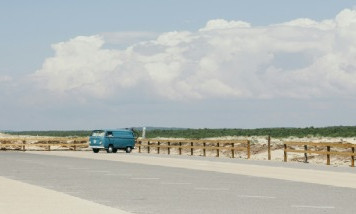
[[0, 176, 129, 214]]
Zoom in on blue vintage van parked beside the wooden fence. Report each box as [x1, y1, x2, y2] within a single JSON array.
[[89, 129, 135, 153]]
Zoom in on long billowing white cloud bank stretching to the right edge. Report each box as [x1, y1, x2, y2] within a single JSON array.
[[33, 9, 356, 100]]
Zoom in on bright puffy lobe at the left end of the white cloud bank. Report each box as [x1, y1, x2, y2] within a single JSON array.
[[33, 36, 122, 97]]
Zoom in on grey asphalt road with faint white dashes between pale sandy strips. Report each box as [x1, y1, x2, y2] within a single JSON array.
[[0, 152, 356, 214]]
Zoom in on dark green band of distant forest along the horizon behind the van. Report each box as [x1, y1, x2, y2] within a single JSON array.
[[6, 126, 356, 139]]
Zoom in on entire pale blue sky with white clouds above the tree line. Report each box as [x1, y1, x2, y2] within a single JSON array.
[[0, 0, 356, 130]]
